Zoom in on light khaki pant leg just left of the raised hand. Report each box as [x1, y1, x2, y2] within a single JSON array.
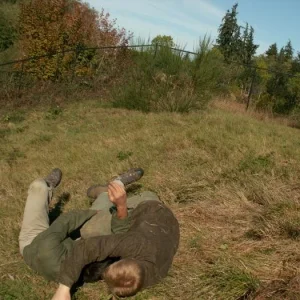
[[80, 192, 113, 239]]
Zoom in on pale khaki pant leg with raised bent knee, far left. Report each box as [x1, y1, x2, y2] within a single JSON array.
[[19, 179, 52, 255]]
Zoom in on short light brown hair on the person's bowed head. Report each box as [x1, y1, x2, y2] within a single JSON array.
[[103, 259, 145, 297]]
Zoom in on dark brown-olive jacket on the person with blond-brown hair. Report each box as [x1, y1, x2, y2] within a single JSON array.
[[58, 201, 179, 288]]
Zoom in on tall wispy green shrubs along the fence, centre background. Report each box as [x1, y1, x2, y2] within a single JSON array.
[[112, 36, 223, 112]]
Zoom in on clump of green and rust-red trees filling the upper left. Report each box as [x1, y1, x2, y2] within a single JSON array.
[[0, 0, 130, 80]]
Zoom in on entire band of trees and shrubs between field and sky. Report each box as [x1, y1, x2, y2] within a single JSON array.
[[0, 0, 300, 119]]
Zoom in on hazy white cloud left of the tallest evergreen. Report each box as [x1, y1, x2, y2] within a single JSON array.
[[88, 0, 225, 50]]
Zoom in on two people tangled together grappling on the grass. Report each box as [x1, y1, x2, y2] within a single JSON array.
[[19, 169, 179, 299]]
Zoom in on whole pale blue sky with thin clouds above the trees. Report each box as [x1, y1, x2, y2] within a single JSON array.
[[87, 0, 300, 53]]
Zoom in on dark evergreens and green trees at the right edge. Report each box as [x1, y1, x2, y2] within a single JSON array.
[[216, 4, 300, 114]]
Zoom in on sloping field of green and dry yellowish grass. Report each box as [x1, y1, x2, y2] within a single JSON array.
[[0, 102, 300, 300]]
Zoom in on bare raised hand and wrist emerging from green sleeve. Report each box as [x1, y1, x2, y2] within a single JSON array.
[[108, 182, 128, 219]]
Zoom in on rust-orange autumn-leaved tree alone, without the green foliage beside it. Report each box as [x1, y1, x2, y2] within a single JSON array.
[[19, 0, 130, 79]]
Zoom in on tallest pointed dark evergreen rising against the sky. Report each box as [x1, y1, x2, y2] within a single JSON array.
[[217, 3, 240, 62]]
